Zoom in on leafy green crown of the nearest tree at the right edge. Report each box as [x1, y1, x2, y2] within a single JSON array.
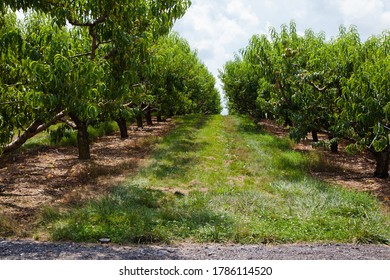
[[340, 32, 390, 152]]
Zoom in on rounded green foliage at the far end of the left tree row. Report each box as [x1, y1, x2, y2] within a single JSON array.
[[148, 33, 221, 116]]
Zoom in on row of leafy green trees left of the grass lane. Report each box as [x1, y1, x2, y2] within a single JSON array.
[[0, 0, 220, 159]]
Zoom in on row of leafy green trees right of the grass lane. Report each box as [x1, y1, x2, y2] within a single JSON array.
[[221, 22, 390, 177]]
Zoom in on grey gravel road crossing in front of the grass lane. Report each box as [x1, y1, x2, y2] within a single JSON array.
[[0, 239, 390, 260]]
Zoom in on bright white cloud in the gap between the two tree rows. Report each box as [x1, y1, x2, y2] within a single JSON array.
[[171, 0, 251, 75]]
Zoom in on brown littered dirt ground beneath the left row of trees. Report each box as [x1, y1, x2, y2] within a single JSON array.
[[0, 121, 174, 237]]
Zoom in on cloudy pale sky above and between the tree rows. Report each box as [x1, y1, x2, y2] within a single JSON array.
[[173, 0, 390, 111]]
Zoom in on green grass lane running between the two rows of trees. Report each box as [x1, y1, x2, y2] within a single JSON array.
[[42, 116, 390, 244]]
